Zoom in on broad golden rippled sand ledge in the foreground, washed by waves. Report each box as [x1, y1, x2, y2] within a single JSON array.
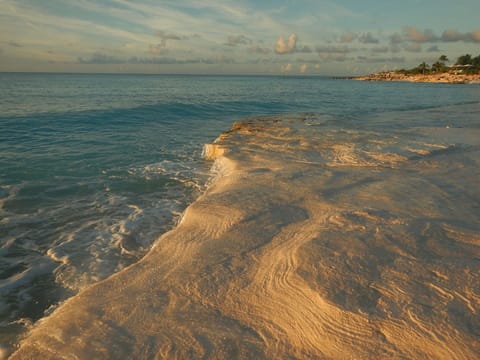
[[12, 111, 480, 359]]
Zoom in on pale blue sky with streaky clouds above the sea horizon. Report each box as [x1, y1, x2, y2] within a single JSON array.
[[0, 0, 480, 76]]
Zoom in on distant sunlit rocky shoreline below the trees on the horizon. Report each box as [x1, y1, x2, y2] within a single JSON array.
[[352, 71, 480, 84]]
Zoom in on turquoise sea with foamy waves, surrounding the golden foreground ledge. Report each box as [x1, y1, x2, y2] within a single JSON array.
[[0, 74, 480, 346]]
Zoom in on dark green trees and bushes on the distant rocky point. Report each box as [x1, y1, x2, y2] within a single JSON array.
[[398, 54, 480, 75]]
